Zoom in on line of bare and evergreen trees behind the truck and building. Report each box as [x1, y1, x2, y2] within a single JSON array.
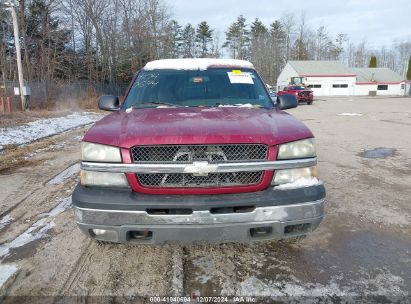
[[0, 0, 411, 102]]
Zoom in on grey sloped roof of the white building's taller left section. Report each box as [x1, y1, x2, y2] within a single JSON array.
[[288, 60, 355, 76]]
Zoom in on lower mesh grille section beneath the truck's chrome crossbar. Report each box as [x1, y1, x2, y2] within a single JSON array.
[[137, 171, 263, 188]]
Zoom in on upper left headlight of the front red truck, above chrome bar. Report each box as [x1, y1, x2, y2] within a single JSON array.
[[81, 142, 121, 163]]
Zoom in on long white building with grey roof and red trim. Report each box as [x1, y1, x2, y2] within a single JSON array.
[[277, 60, 406, 96]]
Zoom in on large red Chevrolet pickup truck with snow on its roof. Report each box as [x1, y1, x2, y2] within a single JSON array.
[[73, 59, 325, 244]]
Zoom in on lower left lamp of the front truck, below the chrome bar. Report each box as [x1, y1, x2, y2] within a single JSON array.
[[80, 170, 128, 188]]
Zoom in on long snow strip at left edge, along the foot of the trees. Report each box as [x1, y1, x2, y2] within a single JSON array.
[[0, 112, 103, 150]]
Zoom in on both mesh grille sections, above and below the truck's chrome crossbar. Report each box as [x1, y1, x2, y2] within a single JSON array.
[[131, 144, 268, 188]]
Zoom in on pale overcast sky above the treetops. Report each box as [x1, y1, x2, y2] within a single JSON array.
[[168, 0, 411, 48]]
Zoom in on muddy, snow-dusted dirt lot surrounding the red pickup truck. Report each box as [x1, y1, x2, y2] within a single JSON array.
[[0, 97, 411, 303]]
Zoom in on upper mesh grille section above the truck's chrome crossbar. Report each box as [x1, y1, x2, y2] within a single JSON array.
[[131, 144, 268, 163]]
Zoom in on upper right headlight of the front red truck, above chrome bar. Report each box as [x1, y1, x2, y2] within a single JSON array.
[[277, 138, 316, 159]]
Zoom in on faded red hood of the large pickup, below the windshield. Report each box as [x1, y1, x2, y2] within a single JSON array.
[[83, 107, 313, 148]]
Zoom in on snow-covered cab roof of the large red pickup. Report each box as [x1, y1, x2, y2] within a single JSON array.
[[144, 58, 254, 70]]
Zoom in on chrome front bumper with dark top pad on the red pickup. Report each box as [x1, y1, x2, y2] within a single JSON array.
[[73, 184, 325, 244]]
